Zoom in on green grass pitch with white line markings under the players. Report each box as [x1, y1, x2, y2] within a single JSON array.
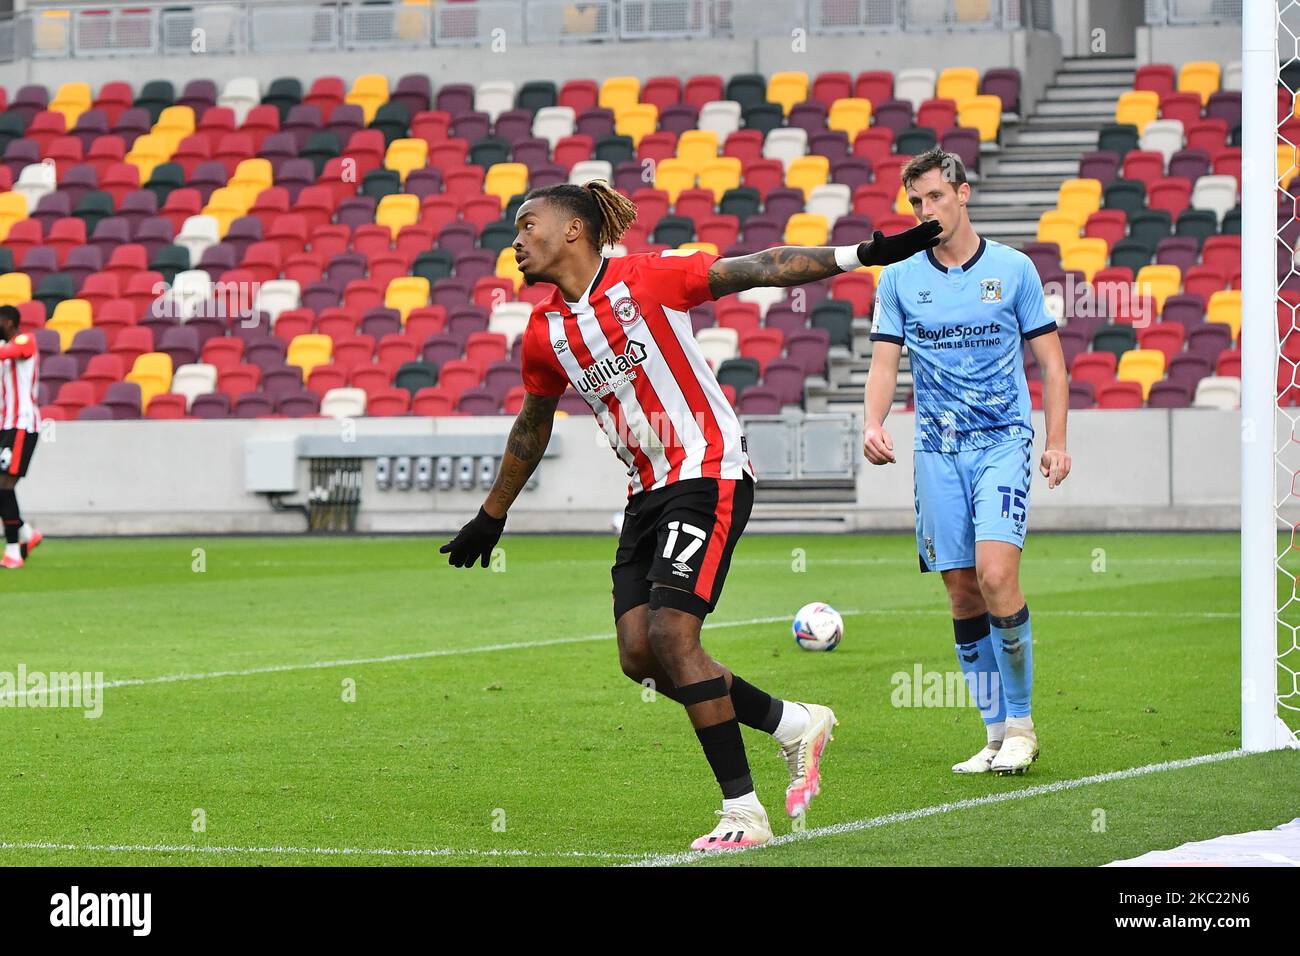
[[0, 533, 1300, 865]]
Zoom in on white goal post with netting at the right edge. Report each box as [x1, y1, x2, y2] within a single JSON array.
[[1240, 0, 1300, 750]]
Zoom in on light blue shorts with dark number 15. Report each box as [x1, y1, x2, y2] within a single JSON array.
[[915, 438, 1034, 571]]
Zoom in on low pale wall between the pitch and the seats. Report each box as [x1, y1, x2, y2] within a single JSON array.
[[20, 410, 1240, 535]]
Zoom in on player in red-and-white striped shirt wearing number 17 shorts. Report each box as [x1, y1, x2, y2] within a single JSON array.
[[442, 181, 939, 851]]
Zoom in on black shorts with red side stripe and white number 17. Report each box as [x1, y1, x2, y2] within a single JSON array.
[[611, 475, 754, 620]]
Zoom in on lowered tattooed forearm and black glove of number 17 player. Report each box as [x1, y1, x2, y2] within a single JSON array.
[[438, 393, 560, 567]]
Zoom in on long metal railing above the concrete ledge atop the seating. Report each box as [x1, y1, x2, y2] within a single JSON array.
[[10, 0, 1045, 61]]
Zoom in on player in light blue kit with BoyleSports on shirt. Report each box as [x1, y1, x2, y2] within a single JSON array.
[[863, 148, 1070, 774]]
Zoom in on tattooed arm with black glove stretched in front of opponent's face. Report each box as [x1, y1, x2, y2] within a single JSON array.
[[709, 221, 943, 299]]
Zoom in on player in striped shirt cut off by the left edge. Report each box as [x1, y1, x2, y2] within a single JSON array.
[[0, 306, 42, 568]]
